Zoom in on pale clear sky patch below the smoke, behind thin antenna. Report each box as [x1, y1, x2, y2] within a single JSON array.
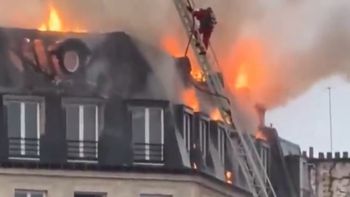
[[266, 76, 350, 155]]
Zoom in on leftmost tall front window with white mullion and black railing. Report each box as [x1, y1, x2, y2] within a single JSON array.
[[4, 96, 45, 159]]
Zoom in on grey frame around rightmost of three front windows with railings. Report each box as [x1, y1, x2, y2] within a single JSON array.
[[128, 104, 165, 165]]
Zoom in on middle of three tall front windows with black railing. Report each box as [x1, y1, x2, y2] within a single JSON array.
[[64, 99, 102, 161]]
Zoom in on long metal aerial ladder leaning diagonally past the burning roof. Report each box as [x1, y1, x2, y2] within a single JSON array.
[[173, 0, 276, 197]]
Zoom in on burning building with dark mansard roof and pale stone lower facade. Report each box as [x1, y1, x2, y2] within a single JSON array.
[[0, 29, 252, 197]]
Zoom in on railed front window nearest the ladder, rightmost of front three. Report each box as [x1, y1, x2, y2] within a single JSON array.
[[129, 107, 164, 163]]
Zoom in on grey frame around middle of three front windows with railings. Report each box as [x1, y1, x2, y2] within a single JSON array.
[[62, 97, 105, 163]]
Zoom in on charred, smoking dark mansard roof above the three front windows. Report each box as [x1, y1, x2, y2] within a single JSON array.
[[0, 28, 174, 98]]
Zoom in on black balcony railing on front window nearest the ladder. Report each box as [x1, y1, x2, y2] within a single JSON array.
[[133, 143, 164, 164]]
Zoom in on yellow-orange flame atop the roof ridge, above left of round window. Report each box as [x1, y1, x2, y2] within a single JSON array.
[[38, 5, 86, 32]]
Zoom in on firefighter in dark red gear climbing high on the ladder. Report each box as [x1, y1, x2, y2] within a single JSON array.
[[187, 7, 217, 54]]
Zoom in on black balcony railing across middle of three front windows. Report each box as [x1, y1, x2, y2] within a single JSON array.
[[67, 140, 98, 161]]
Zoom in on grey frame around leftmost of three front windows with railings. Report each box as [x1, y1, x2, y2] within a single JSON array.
[[3, 95, 46, 161]]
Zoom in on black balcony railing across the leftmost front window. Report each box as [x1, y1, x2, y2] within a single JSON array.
[[8, 137, 40, 159]]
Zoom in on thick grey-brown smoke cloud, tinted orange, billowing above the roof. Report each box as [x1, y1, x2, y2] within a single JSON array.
[[0, 0, 350, 111]]
